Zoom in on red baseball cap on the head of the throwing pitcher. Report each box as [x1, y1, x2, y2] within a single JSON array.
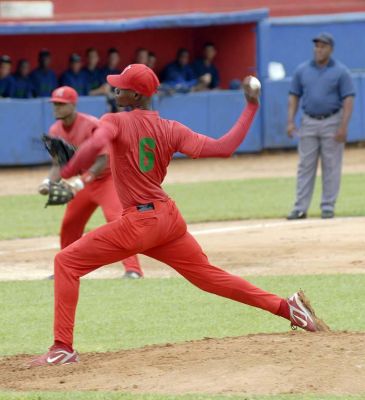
[[106, 64, 160, 97]]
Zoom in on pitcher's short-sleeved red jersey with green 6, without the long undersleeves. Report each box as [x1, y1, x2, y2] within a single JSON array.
[[101, 110, 206, 208]]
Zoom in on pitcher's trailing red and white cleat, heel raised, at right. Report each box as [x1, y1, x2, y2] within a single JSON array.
[[288, 290, 330, 332]]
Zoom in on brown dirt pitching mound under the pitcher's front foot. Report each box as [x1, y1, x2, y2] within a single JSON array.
[[0, 332, 365, 394]]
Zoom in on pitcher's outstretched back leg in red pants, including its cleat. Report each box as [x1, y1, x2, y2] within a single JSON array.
[[144, 232, 328, 332]]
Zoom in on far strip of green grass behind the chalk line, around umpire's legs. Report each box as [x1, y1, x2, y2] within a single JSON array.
[[0, 174, 365, 240]]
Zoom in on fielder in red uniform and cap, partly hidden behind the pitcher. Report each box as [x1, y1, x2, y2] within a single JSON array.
[[38, 86, 143, 278]]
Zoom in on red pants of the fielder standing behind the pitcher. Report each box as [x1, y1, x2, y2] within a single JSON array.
[[60, 175, 143, 276]]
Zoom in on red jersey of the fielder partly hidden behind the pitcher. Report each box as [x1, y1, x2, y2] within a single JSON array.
[[49, 112, 110, 179]]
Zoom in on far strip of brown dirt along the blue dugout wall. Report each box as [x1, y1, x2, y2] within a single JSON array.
[[0, 147, 365, 196]]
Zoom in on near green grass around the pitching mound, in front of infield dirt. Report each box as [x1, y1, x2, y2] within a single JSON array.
[[0, 275, 365, 400]]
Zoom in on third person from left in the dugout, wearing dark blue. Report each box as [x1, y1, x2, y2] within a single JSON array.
[[30, 49, 57, 97]]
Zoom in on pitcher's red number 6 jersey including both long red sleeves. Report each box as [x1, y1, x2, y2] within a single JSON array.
[[61, 103, 258, 208]]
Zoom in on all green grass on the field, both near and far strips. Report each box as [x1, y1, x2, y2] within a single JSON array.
[[0, 174, 365, 400]]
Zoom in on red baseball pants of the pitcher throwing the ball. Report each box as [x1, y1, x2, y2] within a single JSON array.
[[54, 200, 283, 347]]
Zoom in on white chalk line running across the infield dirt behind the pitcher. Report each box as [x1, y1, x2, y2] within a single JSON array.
[[0, 217, 354, 255]]
